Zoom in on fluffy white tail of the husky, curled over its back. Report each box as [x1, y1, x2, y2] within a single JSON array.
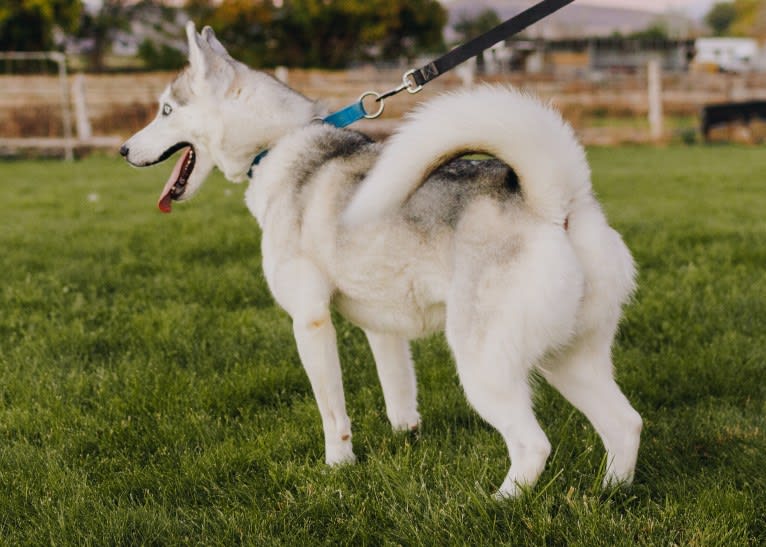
[[343, 86, 591, 226]]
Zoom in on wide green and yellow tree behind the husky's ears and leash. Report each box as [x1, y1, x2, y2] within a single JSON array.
[[192, 0, 447, 68]]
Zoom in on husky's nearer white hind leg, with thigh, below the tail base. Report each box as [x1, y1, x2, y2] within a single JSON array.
[[446, 241, 582, 497]]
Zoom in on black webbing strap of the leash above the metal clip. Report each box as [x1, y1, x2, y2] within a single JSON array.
[[405, 0, 574, 89]]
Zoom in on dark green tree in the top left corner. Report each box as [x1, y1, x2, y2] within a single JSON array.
[[0, 0, 82, 51]]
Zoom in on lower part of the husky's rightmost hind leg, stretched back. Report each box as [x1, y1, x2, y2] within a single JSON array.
[[541, 337, 642, 487]]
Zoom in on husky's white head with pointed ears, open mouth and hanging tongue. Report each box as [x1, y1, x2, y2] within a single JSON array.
[[120, 22, 315, 212]]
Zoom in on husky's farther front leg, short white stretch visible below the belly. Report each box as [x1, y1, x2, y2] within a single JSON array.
[[365, 331, 420, 431]]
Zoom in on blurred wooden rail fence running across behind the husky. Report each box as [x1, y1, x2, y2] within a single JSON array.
[[0, 67, 766, 155]]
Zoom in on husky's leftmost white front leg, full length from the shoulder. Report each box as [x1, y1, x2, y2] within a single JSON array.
[[272, 259, 356, 465]]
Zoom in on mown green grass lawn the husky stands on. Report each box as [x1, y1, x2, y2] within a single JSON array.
[[0, 147, 766, 546]]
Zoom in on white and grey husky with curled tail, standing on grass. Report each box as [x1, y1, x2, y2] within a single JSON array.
[[121, 24, 641, 497]]
